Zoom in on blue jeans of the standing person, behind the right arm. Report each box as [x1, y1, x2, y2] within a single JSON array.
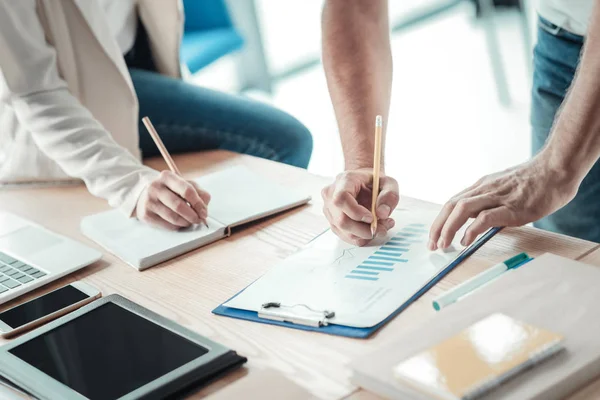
[[531, 18, 600, 242]]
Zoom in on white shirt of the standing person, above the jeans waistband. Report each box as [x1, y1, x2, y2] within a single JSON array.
[[537, 0, 594, 35]]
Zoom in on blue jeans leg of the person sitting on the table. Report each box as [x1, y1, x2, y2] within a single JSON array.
[[125, 17, 313, 168]]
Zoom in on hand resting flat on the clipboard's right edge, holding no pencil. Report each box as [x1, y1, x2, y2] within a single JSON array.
[[428, 155, 579, 250]]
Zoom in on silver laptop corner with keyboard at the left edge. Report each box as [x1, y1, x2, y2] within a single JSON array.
[[0, 211, 102, 304]]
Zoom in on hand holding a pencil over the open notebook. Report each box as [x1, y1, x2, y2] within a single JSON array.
[[135, 171, 210, 230]]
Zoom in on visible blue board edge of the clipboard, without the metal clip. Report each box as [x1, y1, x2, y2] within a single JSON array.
[[212, 228, 502, 339]]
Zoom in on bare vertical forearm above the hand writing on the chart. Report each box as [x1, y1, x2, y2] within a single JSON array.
[[322, 0, 392, 169]]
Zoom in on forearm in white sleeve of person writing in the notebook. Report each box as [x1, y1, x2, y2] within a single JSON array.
[[12, 89, 158, 214]]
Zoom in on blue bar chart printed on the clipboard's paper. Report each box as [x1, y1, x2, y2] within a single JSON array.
[[346, 224, 428, 281]]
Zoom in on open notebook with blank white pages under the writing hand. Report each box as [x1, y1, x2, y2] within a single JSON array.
[[81, 167, 310, 271]]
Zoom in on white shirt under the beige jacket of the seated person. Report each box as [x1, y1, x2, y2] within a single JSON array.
[[98, 0, 137, 54]]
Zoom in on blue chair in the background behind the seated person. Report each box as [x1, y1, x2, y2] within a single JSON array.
[[181, 0, 244, 74]]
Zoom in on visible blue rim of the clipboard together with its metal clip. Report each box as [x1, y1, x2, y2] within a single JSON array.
[[212, 227, 502, 339]]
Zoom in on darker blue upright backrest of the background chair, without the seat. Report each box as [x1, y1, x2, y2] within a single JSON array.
[[183, 0, 233, 32]]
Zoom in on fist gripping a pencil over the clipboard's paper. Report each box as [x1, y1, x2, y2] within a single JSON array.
[[321, 168, 400, 246]]
